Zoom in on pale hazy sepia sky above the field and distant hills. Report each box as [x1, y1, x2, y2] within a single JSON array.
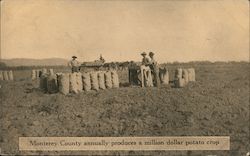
[[1, 0, 249, 63]]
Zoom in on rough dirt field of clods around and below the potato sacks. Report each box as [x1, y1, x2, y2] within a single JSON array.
[[0, 63, 250, 156]]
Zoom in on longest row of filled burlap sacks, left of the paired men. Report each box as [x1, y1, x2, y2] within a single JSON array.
[[40, 71, 119, 95]]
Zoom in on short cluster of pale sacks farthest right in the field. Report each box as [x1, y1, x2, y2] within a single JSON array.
[[174, 68, 195, 88]]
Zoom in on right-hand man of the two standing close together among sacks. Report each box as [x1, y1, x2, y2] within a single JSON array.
[[149, 52, 160, 87]]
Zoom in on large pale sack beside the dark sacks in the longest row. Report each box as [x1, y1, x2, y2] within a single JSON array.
[[56, 73, 69, 95]]
